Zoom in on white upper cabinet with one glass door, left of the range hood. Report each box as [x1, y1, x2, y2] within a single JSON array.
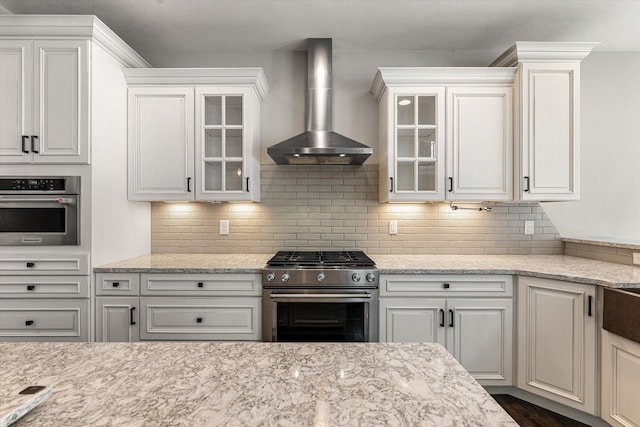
[[125, 68, 267, 202]]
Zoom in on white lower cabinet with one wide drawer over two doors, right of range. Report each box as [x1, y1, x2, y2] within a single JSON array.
[[380, 275, 513, 385]]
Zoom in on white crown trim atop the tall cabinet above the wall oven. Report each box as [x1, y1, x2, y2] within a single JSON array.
[[0, 15, 150, 68]]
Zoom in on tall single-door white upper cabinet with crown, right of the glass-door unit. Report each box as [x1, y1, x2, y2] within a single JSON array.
[[492, 42, 598, 201]]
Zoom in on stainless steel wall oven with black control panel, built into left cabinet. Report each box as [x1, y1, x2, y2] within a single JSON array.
[[0, 176, 80, 246]]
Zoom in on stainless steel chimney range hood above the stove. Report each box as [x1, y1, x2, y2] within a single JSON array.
[[267, 39, 373, 165]]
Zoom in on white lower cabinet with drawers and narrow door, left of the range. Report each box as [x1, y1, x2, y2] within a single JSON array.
[[96, 273, 262, 342]]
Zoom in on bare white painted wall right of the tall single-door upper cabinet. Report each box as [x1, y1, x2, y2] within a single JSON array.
[[542, 51, 640, 241]]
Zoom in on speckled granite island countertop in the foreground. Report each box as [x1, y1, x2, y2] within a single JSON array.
[[0, 342, 517, 427]]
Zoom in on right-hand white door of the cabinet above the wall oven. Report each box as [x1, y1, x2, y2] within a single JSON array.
[[32, 40, 89, 163]]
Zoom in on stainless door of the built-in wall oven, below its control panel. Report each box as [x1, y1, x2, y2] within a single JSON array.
[[0, 194, 79, 246]]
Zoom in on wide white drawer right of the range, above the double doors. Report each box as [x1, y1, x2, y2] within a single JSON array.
[[380, 274, 513, 297]]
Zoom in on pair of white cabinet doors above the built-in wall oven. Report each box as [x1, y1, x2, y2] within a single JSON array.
[[0, 39, 89, 163]]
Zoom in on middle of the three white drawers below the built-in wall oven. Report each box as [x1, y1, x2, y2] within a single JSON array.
[[0, 276, 89, 298]]
